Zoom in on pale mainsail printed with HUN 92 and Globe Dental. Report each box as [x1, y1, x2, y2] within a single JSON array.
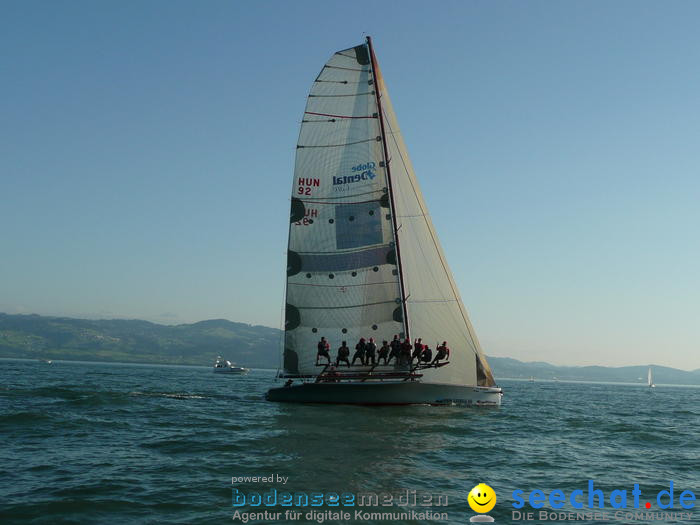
[[284, 45, 404, 374]]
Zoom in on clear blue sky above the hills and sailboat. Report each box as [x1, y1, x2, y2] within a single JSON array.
[[0, 1, 700, 369]]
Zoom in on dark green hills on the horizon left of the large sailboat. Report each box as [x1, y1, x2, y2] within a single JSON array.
[[0, 313, 280, 368]]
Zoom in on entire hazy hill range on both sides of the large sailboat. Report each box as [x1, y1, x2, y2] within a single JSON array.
[[0, 313, 700, 385]]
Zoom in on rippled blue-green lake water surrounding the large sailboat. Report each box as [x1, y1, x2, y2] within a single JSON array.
[[0, 360, 700, 524]]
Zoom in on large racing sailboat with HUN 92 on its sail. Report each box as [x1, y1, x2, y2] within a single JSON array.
[[266, 37, 502, 406]]
